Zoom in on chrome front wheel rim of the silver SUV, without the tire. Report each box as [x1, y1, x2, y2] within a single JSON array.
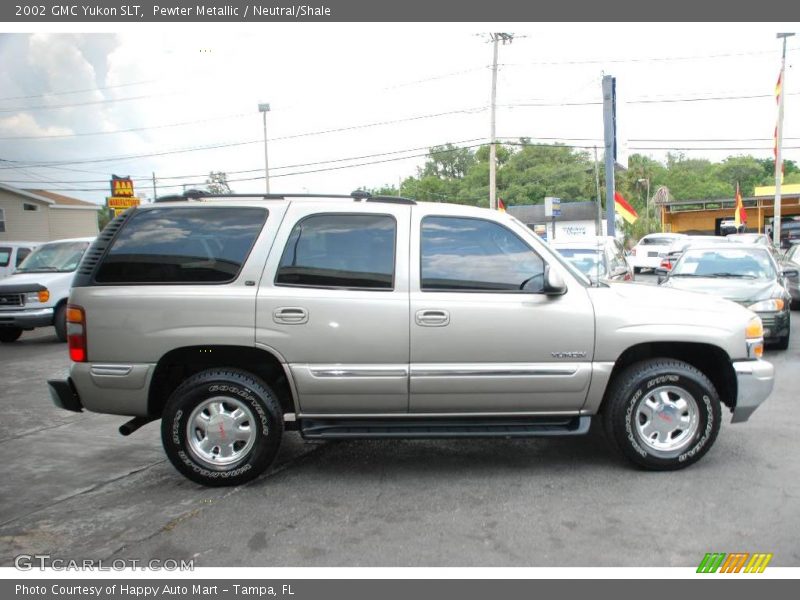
[[634, 386, 700, 458]]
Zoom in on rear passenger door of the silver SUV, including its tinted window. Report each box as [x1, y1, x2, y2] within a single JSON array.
[[256, 201, 410, 416]]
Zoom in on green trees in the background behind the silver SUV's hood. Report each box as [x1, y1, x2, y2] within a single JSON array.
[[382, 138, 800, 219]]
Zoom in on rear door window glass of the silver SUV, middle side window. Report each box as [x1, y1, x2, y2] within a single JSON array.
[[275, 214, 397, 290]]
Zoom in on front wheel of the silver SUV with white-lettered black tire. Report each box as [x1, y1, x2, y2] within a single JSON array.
[[602, 358, 722, 471]]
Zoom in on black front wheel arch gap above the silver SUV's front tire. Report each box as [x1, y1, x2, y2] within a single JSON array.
[[600, 342, 738, 412]]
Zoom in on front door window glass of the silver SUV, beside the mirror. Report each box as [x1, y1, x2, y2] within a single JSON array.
[[421, 217, 544, 291]]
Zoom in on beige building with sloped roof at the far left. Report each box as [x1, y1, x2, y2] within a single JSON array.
[[0, 183, 102, 242]]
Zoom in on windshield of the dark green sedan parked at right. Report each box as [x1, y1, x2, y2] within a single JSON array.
[[672, 248, 777, 279]]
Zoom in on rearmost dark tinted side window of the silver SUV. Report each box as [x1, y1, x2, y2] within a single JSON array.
[[95, 206, 267, 284]]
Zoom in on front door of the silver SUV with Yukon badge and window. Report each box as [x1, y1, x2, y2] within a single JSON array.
[[410, 205, 594, 414]]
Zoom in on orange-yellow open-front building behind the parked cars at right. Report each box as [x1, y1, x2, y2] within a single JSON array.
[[659, 183, 800, 235]]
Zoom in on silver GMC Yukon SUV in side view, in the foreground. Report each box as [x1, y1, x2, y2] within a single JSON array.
[[49, 193, 773, 485]]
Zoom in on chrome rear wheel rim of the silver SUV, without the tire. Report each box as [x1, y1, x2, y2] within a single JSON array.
[[186, 396, 256, 470]]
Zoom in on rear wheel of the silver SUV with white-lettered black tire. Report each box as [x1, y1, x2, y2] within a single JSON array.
[[161, 368, 283, 486]]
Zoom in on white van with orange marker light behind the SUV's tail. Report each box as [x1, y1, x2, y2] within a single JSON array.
[[0, 238, 94, 343]]
